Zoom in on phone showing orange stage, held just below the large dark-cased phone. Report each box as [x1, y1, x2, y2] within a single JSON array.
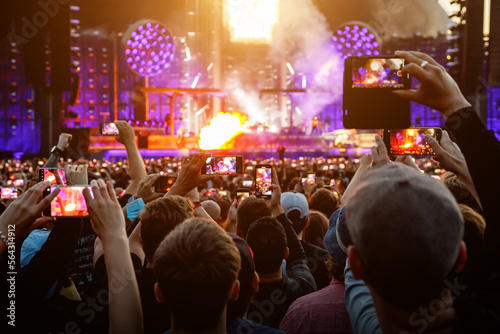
[[384, 128, 443, 156]]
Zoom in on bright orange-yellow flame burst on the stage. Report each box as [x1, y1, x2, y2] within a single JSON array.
[[198, 112, 246, 150]]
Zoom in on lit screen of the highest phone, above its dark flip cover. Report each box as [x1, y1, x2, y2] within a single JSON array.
[[352, 58, 405, 89]]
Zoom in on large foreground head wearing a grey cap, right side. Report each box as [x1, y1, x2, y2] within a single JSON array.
[[346, 163, 467, 310]]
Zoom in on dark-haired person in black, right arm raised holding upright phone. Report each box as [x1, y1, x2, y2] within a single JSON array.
[[246, 180, 316, 328]]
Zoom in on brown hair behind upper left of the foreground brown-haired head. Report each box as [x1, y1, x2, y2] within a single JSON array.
[[139, 195, 194, 263]]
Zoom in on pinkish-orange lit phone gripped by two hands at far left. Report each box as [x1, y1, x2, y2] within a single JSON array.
[[44, 186, 92, 217]]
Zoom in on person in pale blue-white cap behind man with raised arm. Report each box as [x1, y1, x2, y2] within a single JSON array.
[[281, 192, 330, 290]]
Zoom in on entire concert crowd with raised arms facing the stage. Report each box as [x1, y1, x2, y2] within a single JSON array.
[[0, 52, 500, 333]]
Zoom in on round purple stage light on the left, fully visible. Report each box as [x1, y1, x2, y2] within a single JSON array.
[[125, 22, 175, 77]]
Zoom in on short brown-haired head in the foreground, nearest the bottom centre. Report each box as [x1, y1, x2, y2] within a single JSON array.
[[153, 218, 240, 331]]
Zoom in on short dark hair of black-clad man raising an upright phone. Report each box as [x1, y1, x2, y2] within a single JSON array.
[[247, 217, 287, 274]]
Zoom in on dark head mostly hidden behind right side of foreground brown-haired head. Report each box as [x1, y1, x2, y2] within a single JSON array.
[[227, 233, 259, 319]]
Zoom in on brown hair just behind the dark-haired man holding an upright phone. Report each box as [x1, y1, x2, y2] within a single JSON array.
[[236, 197, 271, 239]]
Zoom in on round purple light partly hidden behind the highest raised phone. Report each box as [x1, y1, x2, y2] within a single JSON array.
[[332, 21, 381, 58]]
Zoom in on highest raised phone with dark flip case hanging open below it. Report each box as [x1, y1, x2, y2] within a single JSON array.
[[343, 56, 411, 129]]
